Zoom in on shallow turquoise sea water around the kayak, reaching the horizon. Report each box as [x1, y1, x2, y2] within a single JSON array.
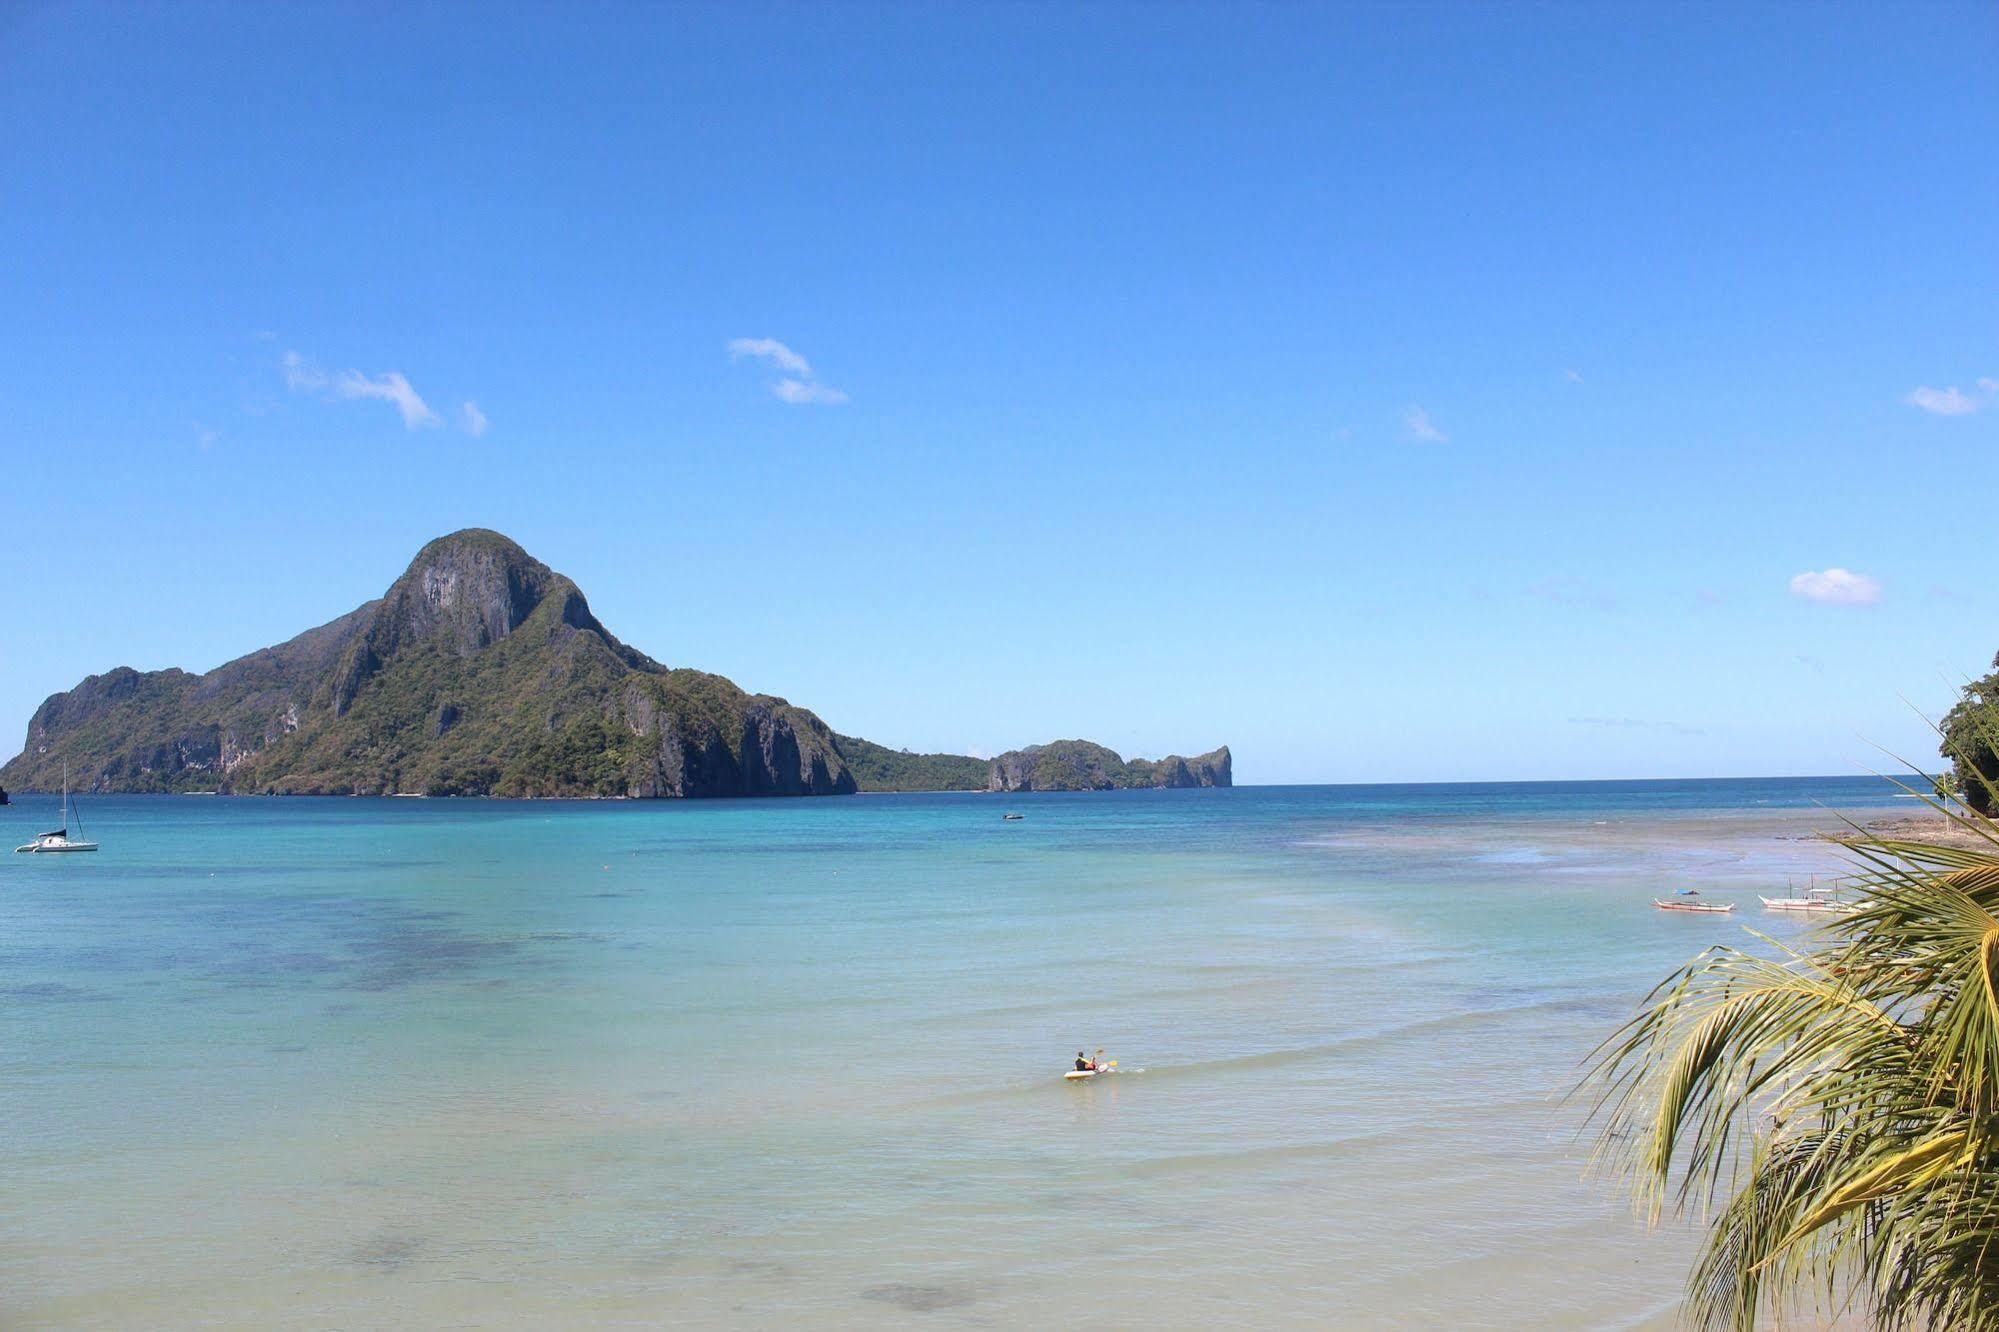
[[0, 778, 1909, 1328]]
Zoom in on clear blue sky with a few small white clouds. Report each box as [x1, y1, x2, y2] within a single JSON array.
[[0, 4, 1999, 782]]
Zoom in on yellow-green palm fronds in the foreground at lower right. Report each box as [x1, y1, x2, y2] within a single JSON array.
[[1587, 804, 1999, 1332]]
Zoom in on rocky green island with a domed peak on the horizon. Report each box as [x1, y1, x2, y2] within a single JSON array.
[[0, 528, 1231, 798]]
